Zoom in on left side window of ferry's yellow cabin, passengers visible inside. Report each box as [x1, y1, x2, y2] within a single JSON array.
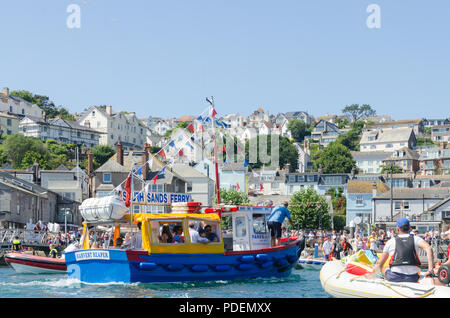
[[150, 220, 185, 244]]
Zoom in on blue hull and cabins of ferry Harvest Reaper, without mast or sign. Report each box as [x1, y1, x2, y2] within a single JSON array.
[[66, 201, 305, 283]]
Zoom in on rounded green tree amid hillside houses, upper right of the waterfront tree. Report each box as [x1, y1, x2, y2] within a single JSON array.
[[313, 142, 356, 173]]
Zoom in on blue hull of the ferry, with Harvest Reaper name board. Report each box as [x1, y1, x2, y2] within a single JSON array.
[[66, 241, 303, 283]]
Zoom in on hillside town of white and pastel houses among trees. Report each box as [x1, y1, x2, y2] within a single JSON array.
[[0, 88, 450, 234]]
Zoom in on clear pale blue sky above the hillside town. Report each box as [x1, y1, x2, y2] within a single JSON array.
[[0, 0, 450, 119]]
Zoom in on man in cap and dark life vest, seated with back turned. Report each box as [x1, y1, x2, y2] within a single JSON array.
[[369, 218, 434, 283]]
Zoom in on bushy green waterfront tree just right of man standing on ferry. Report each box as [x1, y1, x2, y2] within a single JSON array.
[[289, 187, 331, 229]]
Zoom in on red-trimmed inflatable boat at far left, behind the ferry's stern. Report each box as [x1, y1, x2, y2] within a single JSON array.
[[5, 252, 67, 274]]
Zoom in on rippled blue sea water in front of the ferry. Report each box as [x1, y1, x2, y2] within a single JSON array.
[[0, 266, 329, 298]]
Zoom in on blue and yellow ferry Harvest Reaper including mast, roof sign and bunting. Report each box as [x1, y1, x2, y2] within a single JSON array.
[[65, 101, 305, 283]]
